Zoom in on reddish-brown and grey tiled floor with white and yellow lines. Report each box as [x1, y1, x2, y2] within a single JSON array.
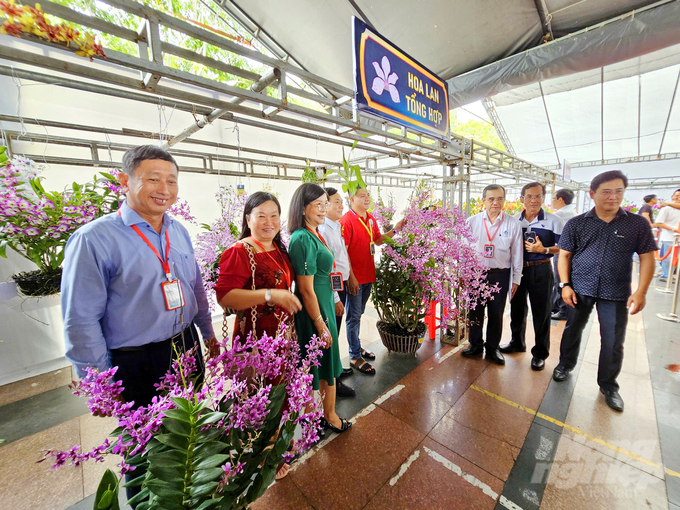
[[0, 288, 680, 510]]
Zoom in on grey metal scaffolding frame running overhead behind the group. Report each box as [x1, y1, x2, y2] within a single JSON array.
[[0, 0, 584, 209]]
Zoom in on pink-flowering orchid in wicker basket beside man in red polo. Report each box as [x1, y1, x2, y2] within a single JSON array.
[[371, 192, 492, 353]]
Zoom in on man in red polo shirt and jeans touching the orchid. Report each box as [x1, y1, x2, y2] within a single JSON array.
[[340, 188, 404, 375]]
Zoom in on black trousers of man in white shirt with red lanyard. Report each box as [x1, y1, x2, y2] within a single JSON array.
[[469, 269, 510, 349]]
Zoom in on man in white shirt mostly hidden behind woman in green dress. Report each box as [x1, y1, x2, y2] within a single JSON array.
[[319, 188, 356, 397]]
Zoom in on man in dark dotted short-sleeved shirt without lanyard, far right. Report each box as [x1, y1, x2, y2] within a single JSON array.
[[553, 170, 657, 411]]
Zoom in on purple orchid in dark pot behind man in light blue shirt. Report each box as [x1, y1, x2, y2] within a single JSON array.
[[0, 151, 121, 297]]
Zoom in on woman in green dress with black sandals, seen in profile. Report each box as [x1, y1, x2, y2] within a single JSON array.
[[288, 183, 352, 433]]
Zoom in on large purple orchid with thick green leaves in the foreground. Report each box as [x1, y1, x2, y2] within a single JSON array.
[[43, 326, 322, 510]]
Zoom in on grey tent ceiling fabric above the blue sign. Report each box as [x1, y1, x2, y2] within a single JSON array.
[[232, 0, 653, 94]]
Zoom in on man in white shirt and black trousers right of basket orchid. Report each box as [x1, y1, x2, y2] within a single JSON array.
[[462, 184, 524, 365]]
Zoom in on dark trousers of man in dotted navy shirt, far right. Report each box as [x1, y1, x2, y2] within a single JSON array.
[[560, 294, 628, 391]]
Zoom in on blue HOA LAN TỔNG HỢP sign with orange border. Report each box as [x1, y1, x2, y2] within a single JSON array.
[[352, 17, 449, 138]]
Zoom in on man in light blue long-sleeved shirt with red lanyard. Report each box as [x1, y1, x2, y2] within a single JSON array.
[[61, 145, 216, 407]]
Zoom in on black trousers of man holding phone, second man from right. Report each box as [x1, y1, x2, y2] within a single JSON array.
[[510, 261, 554, 359]]
